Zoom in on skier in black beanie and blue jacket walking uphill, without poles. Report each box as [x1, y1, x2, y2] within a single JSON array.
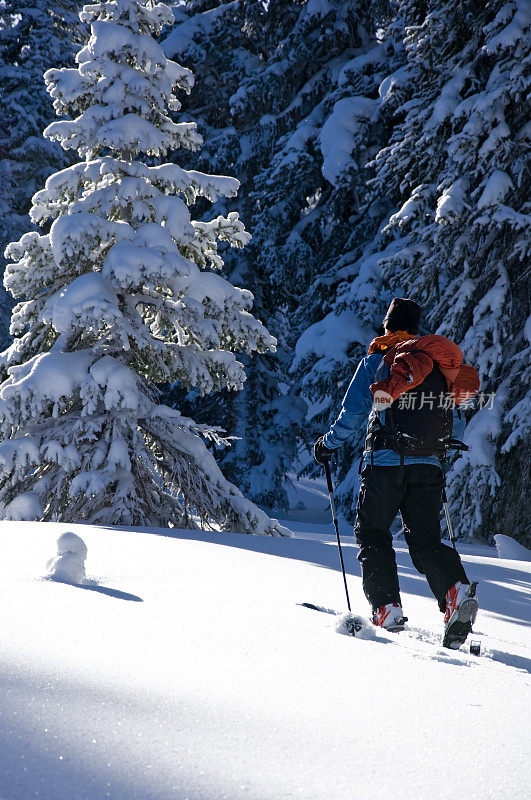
[[314, 297, 479, 648]]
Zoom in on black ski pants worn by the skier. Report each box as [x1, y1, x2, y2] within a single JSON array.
[[354, 464, 468, 611]]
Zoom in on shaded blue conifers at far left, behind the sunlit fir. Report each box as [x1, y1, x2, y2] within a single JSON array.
[[0, 0, 84, 344]]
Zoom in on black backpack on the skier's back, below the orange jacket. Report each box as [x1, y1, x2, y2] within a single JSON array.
[[365, 359, 454, 459]]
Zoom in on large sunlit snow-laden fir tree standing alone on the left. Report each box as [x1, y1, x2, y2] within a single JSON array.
[[0, 0, 283, 534]]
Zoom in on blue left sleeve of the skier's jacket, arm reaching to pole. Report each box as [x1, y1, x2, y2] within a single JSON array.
[[324, 353, 382, 450]]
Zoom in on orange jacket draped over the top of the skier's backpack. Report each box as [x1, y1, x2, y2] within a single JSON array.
[[371, 334, 479, 405]]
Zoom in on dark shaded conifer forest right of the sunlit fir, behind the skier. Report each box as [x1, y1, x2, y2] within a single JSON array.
[[163, 0, 531, 541]]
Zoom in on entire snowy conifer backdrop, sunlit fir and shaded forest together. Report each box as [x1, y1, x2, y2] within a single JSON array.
[[0, 0, 531, 541]]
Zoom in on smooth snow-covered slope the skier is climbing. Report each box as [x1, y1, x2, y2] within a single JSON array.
[[0, 522, 531, 800]]
